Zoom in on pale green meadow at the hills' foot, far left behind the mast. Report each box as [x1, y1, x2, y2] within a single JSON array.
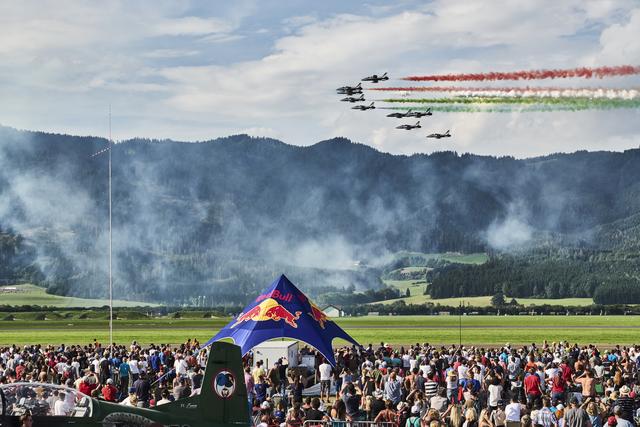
[[0, 285, 157, 307]]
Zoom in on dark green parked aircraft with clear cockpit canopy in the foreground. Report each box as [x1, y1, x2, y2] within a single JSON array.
[[0, 342, 250, 427]]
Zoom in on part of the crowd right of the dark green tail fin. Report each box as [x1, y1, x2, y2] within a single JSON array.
[[245, 342, 640, 427]]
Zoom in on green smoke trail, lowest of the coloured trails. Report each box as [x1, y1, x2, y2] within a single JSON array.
[[382, 96, 640, 111]]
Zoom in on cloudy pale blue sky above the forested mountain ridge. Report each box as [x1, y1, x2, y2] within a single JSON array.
[[0, 0, 640, 158]]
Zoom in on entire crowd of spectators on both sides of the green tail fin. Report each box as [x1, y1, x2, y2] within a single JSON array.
[[0, 340, 640, 427]]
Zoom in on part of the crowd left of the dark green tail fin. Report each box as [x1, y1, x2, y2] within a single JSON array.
[[0, 339, 207, 415]]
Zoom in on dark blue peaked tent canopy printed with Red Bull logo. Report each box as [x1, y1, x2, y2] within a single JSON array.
[[204, 274, 360, 366]]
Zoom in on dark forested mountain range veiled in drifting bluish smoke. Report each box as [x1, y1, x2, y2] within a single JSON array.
[[0, 127, 640, 302]]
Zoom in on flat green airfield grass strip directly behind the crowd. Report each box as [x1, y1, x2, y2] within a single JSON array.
[[0, 316, 640, 346]]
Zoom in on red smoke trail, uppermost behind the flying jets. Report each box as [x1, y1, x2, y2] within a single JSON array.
[[402, 65, 640, 82]]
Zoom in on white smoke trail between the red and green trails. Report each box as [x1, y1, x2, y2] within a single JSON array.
[[369, 86, 640, 99]]
